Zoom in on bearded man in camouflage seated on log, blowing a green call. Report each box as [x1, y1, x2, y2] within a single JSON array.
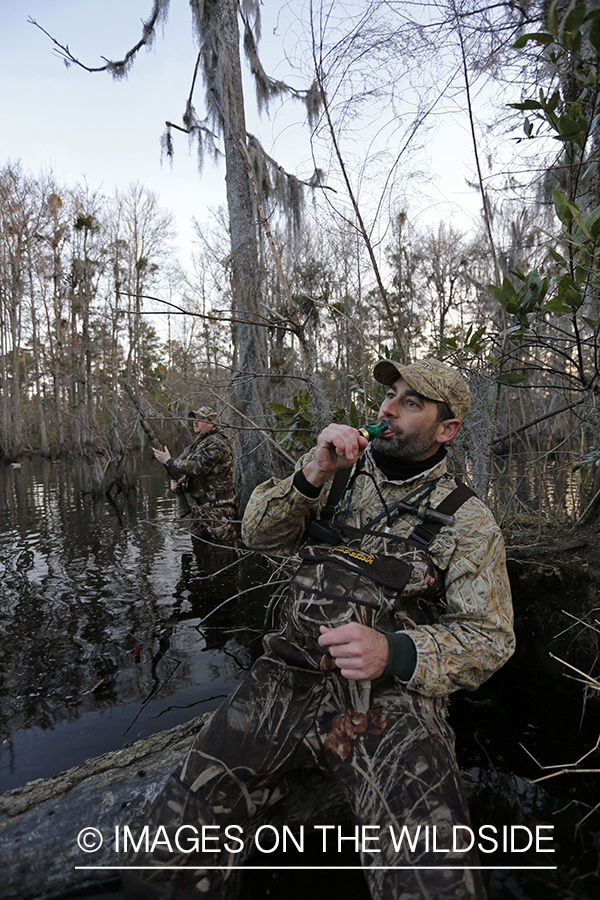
[[124, 360, 514, 900]]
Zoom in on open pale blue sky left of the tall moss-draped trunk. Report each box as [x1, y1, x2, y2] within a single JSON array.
[[0, 0, 230, 255]]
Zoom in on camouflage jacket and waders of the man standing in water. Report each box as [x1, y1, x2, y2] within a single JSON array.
[[166, 428, 238, 543]]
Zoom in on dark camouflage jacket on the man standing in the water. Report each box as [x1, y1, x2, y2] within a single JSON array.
[[166, 428, 234, 509]]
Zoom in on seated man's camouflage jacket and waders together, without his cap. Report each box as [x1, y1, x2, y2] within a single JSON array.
[[124, 451, 514, 900]]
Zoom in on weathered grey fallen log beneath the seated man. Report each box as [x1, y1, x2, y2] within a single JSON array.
[[0, 713, 349, 900]]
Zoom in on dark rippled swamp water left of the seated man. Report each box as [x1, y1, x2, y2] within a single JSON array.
[[0, 460, 265, 790]]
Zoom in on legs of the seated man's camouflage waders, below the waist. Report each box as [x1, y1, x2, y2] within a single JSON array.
[[123, 653, 485, 900]]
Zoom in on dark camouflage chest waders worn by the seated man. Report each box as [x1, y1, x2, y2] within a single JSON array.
[[124, 529, 485, 900]]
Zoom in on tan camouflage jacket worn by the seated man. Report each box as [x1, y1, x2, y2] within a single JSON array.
[[242, 450, 514, 696]]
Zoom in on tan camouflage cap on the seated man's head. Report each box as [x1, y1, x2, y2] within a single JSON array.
[[373, 359, 471, 422]]
